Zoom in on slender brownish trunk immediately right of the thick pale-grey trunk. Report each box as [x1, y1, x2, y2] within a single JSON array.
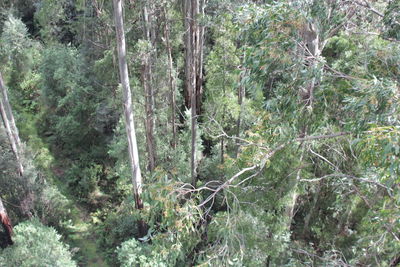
[[142, 1, 156, 172]]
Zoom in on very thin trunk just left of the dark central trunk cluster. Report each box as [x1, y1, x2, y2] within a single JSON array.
[[163, 6, 176, 149]]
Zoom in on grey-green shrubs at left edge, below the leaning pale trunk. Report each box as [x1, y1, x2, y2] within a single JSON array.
[[0, 128, 70, 229]]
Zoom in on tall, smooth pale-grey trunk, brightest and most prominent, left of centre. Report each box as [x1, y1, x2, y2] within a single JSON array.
[[113, 0, 144, 218]]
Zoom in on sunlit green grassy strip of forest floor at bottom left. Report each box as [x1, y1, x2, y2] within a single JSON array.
[[53, 168, 109, 267]]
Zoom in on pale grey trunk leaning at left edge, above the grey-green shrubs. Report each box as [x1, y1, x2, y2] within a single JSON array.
[[0, 73, 24, 175]]
